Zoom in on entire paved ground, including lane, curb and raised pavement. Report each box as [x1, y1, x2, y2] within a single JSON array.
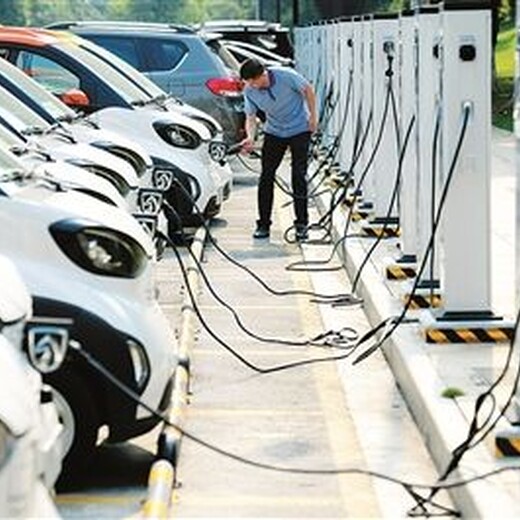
[[54, 127, 520, 518]]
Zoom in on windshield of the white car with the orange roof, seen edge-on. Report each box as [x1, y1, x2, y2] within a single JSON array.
[[58, 38, 153, 104]]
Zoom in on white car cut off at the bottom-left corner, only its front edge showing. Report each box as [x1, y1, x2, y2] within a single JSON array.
[[0, 255, 67, 519]]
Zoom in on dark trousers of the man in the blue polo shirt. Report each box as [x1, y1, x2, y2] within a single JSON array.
[[257, 132, 311, 227]]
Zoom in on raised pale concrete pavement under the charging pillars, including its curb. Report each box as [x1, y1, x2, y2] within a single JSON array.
[[305, 130, 520, 518]]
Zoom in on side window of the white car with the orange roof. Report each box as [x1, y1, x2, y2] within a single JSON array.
[[15, 51, 80, 94]]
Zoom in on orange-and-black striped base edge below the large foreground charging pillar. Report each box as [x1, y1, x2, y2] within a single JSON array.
[[424, 327, 513, 343]]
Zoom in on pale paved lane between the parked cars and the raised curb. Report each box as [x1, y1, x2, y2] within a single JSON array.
[[172, 156, 450, 518]]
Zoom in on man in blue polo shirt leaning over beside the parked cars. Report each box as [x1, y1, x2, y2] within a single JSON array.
[[240, 59, 317, 241]]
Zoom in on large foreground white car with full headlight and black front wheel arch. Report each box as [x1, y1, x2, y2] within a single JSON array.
[[0, 149, 178, 480]]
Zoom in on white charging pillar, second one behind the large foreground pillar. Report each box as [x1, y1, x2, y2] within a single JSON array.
[[398, 11, 418, 263]]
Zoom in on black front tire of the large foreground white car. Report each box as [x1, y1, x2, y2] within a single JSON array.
[[47, 370, 99, 481]]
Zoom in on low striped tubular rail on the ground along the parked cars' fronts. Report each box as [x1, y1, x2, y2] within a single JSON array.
[[141, 226, 206, 519]]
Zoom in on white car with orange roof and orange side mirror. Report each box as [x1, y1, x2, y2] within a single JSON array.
[[0, 27, 230, 234]]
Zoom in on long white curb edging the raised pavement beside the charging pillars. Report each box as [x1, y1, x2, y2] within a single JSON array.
[[316, 182, 519, 518]]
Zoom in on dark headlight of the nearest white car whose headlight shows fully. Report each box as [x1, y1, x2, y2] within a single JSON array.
[[49, 219, 148, 278]]
